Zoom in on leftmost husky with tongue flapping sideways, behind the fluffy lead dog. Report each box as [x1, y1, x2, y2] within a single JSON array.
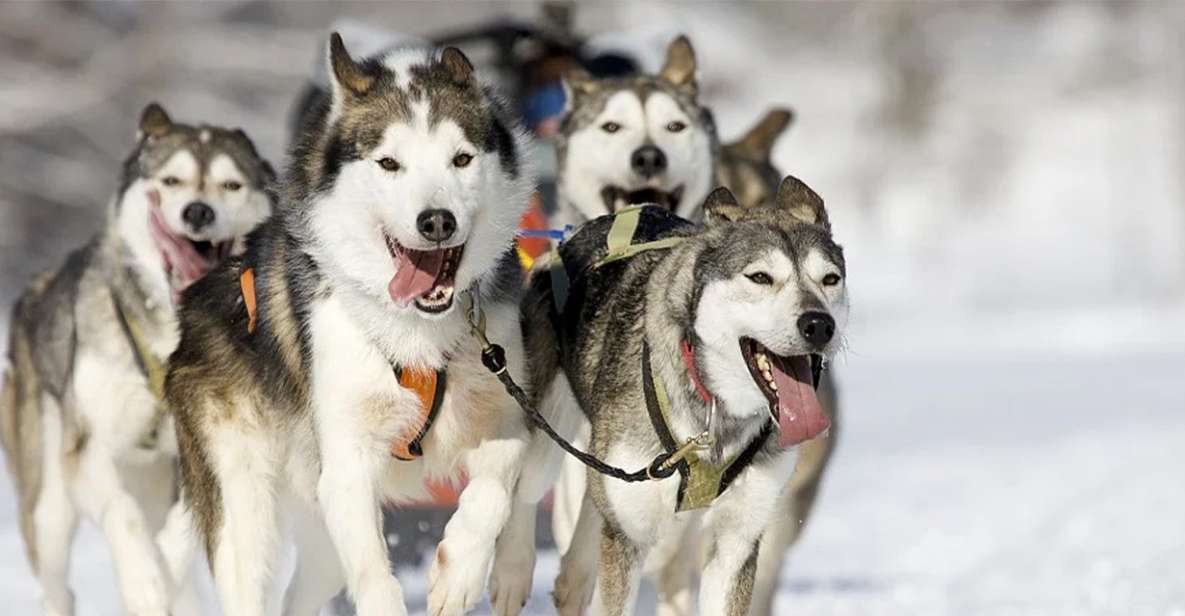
[[0, 104, 274, 615]]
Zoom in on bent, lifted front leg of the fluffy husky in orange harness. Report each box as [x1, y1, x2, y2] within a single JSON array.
[[428, 433, 534, 616]]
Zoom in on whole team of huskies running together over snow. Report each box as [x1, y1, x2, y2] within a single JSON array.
[[0, 34, 847, 616]]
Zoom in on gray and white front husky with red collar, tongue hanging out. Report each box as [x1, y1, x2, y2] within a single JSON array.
[[523, 178, 847, 615]]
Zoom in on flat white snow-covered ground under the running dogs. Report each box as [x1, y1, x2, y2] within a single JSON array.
[[0, 353, 1185, 616]]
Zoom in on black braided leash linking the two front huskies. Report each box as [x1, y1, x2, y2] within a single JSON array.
[[467, 290, 690, 483]]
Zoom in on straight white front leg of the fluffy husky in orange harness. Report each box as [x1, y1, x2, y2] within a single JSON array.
[[319, 431, 408, 616]]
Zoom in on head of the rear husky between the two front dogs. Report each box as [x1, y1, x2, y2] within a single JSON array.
[[555, 37, 719, 224]]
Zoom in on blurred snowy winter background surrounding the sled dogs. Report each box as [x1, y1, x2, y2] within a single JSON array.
[[0, 1, 1185, 615]]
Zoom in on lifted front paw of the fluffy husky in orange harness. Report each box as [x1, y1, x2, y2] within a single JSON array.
[[428, 538, 489, 616]]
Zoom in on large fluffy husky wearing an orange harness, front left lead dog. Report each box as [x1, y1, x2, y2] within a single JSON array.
[[166, 34, 532, 616]]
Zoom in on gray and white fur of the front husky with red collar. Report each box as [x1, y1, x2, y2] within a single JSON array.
[[524, 178, 847, 615]]
